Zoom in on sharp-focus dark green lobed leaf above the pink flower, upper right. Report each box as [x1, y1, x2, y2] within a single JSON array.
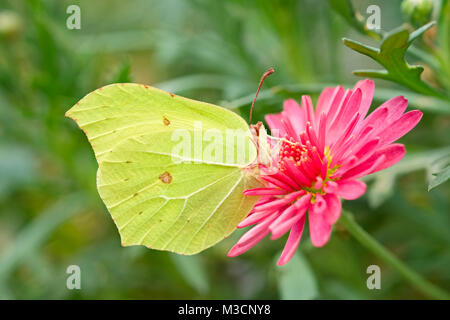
[[343, 22, 449, 100]]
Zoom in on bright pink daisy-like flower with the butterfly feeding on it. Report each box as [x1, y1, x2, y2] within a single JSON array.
[[228, 80, 422, 265]]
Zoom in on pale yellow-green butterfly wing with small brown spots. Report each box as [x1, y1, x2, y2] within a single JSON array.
[[67, 84, 259, 254]]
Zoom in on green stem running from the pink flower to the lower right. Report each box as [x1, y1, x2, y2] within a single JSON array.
[[339, 210, 450, 300]]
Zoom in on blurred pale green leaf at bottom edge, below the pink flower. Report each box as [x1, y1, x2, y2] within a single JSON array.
[[277, 253, 319, 300]]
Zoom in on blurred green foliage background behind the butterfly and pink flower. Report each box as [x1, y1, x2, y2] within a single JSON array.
[[0, 0, 450, 299]]
